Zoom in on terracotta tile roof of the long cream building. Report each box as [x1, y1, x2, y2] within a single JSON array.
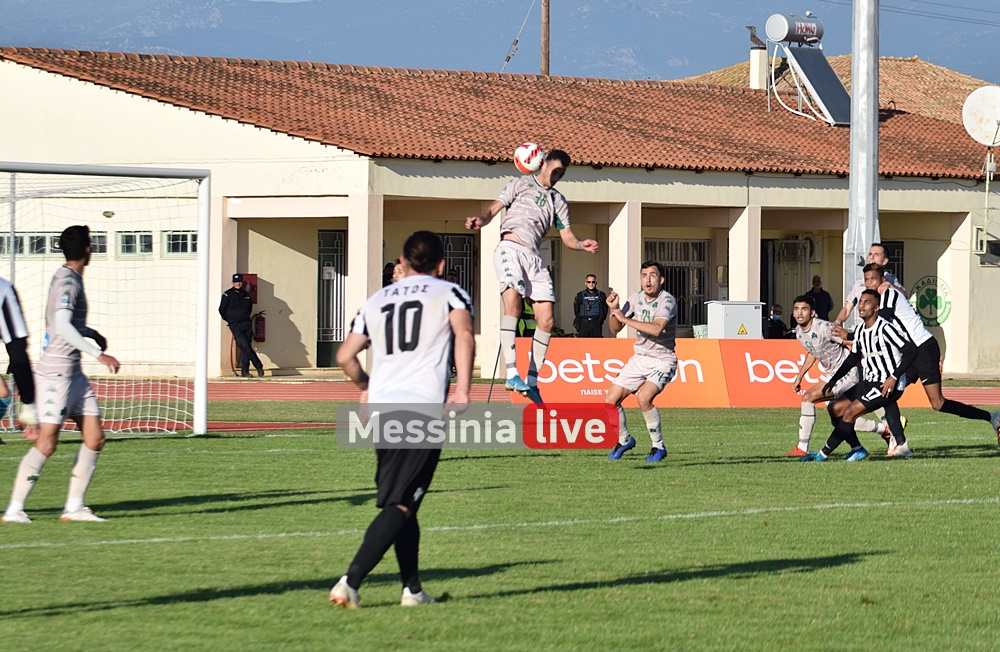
[[0, 47, 982, 178]]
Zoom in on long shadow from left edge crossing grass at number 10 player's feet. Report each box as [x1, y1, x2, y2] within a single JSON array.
[[0, 561, 554, 619]]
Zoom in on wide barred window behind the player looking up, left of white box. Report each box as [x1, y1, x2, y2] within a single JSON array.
[[630, 238, 712, 326]]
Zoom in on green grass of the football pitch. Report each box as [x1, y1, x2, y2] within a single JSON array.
[[0, 402, 1000, 650]]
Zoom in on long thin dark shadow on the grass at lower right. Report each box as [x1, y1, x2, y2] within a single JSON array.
[[467, 552, 887, 599]]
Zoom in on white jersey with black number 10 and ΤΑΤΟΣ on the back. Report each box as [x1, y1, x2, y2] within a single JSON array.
[[351, 274, 472, 403]]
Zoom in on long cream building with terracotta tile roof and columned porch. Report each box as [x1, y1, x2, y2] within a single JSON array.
[[0, 48, 1000, 374]]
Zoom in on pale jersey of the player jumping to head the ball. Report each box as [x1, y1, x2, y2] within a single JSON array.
[[497, 174, 569, 256]]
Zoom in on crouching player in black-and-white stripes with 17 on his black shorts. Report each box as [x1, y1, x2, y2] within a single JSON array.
[[800, 290, 917, 462]]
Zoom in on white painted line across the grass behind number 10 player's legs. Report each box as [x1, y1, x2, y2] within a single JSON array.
[[0, 497, 1000, 550]]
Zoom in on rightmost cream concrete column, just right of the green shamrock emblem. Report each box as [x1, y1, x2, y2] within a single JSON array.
[[940, 213, 976, 373]]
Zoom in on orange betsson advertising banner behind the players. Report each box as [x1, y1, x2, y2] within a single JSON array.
[[511, 338, 930, 407]]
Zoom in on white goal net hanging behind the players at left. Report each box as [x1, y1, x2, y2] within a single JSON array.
[[0, 163, 208, 433]]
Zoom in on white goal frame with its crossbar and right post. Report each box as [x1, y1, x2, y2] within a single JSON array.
[[0, 161, 212, 435]]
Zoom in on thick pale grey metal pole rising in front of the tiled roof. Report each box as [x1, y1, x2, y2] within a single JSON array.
[[844, 0, 881, 326]]
